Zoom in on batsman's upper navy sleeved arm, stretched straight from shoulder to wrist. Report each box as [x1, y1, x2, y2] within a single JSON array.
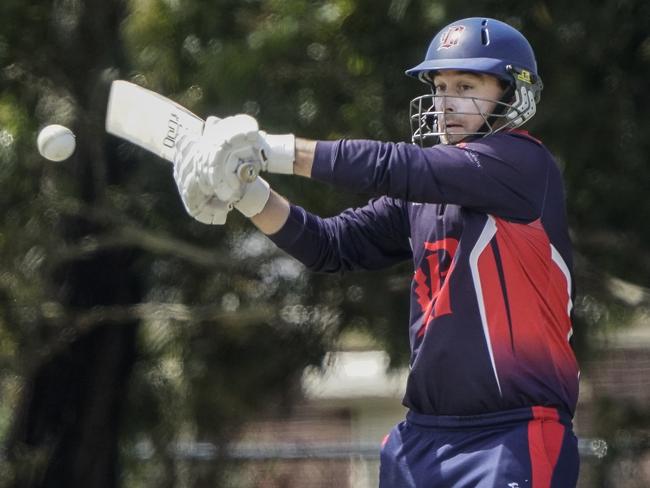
[[311, 137, 554, 222]]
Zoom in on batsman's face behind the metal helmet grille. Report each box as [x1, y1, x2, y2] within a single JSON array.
[[433, 70, 503, 144]]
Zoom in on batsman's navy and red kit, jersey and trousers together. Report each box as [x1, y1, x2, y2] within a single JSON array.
[[270, 131, 579, 488]]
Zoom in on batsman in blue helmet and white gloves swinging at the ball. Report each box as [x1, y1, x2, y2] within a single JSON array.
[[174, 18, 579, 488]]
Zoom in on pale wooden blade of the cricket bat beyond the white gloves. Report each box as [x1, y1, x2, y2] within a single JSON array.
[[106, 80, 204, 162]]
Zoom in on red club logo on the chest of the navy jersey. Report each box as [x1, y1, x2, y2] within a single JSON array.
[[414, 237, 458, 337]]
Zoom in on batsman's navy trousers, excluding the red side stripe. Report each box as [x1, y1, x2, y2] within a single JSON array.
[[379, 408, 579, 488]]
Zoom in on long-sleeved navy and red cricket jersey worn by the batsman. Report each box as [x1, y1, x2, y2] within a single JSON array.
[[270, 131, 578, 415]]
